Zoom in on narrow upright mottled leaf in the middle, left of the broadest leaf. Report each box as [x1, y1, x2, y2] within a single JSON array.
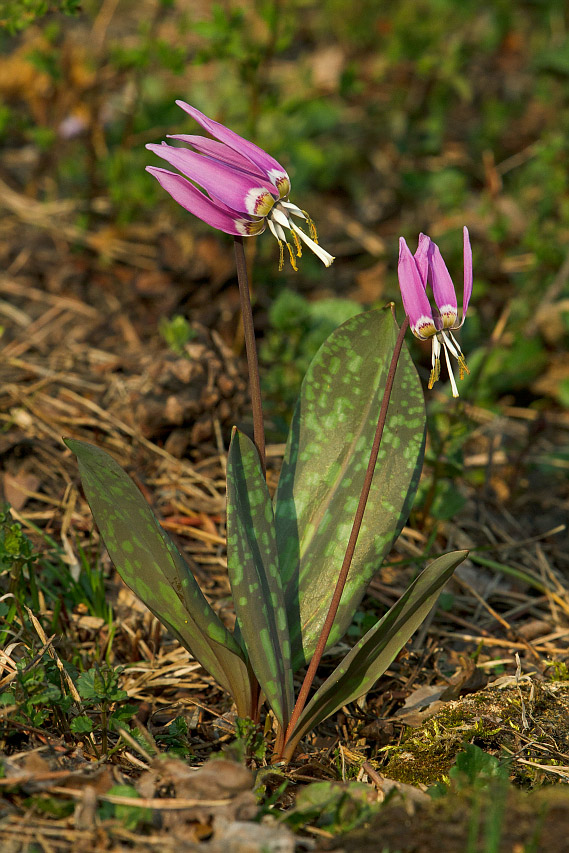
[[227, 429, 294, 728]]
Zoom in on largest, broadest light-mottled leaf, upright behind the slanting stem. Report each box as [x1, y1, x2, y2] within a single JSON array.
[[275, 309, 425, 669]]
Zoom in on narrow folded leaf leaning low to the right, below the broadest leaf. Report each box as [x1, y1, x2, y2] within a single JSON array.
[[285, 551, 468, 755]]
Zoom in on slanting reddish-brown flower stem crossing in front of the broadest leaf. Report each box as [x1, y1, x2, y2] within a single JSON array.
[[282, 317, 409, 758]]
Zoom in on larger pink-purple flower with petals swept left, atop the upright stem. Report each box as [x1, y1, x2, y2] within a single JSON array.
[[146, 101, 334, 269]]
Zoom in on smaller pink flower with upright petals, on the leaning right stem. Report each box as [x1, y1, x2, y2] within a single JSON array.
[[397, 227, 472, 397]]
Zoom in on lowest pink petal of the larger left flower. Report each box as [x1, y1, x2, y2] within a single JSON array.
[[146, 166, 262, 236]]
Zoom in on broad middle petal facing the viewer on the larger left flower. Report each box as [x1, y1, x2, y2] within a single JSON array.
[[146, 142, 276, 216]]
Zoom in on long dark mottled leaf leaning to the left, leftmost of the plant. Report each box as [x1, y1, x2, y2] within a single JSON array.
[[66, 440, 251, 716]]
